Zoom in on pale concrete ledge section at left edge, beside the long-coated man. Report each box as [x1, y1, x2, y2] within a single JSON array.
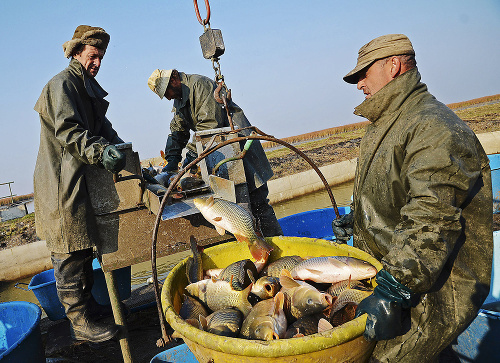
[[0, 241, 52, 281]]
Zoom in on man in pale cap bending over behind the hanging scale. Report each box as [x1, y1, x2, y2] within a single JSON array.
[[148, 69, 283, 237]]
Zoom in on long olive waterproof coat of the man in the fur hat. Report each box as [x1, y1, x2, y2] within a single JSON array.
[[34, 59, 121, 253]]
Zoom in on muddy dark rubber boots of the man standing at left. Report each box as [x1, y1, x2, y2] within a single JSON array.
[[51, 249, 118, 343]]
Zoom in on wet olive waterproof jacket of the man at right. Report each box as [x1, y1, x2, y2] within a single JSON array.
[[353, 68, 493, 362]]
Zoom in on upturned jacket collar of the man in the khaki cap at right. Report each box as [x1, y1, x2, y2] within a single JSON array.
[[354, 67, 427, 122]]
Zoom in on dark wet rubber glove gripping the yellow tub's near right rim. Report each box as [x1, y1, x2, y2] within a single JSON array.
[[355, 270, 412, 341]]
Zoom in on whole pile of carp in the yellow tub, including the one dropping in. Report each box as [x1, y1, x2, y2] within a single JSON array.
[[179, 198, 377, 340]]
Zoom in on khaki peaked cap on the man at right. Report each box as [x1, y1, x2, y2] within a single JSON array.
[[344, 34, 415, 84]]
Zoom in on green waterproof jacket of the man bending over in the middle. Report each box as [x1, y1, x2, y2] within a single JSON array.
[[165, 72, 273, 191]]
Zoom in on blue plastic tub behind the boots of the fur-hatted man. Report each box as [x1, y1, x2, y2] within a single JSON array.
[[16, 259, 131, 321]]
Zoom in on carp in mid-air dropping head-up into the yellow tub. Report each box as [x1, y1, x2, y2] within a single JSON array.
[[193, 196, 273, 264]]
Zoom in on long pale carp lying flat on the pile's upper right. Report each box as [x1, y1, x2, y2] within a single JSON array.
[[291, 256, 377, 284]]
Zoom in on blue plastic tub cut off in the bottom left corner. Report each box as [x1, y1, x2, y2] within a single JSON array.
[[0, 301, 45, 363]]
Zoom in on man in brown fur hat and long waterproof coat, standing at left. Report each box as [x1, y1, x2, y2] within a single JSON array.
[[34, 25, 125, 342]]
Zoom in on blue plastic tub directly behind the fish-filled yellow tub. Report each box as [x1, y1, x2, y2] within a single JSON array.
[[278, 207, 352, 246]]
